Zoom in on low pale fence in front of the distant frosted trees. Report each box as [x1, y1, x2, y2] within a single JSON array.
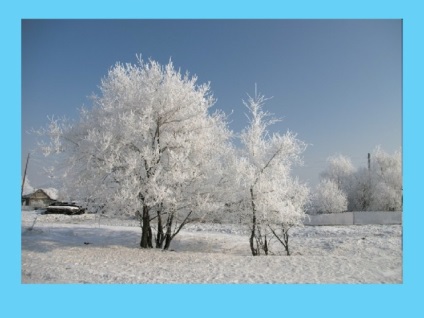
[[304, 211, 402, 225]]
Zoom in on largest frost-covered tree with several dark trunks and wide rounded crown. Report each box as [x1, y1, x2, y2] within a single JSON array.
[[37, 58, 230, 248]]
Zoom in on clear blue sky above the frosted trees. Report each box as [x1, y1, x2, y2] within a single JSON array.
[[22, 20, 402, 187]]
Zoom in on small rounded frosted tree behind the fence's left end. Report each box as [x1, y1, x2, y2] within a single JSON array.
[[312, 179, 347, 213]]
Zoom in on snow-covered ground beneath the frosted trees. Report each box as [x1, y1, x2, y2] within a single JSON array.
[[22, 211, 402, 284]]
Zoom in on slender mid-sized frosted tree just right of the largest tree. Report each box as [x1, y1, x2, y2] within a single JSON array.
[[235, 92, 308, 256]]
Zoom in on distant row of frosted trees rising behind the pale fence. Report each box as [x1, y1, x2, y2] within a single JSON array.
[[309, 147, 403, 213]]
